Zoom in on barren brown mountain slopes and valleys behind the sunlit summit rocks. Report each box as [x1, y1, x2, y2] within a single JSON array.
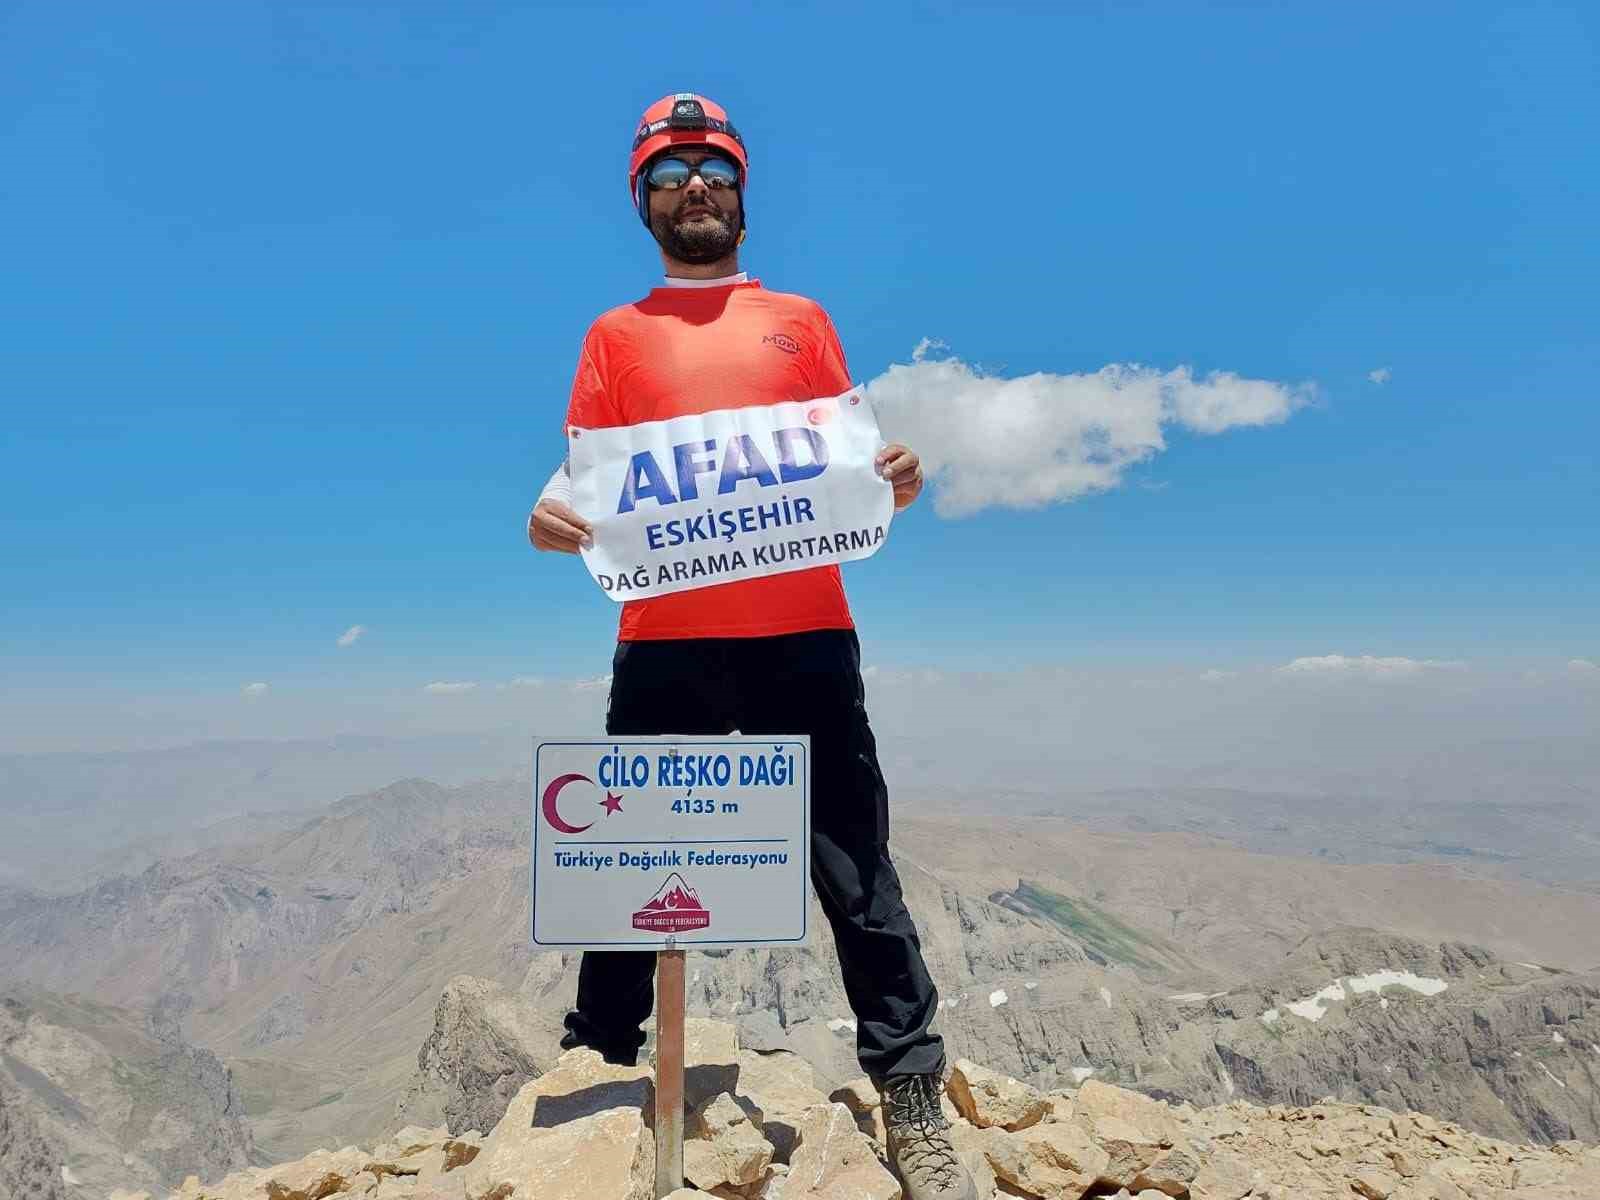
[[0, 764, 1600, 1195]]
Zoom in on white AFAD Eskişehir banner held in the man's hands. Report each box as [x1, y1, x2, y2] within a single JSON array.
[[568, 390, 894, 602]]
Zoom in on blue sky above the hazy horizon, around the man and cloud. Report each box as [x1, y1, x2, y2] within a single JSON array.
[[0, 2, 1600, 752]]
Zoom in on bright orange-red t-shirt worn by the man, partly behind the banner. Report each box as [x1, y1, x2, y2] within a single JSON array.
[[566, 275, 851, 642]]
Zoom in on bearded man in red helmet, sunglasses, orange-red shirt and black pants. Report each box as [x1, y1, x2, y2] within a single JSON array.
[[528, 94, 976, 1200]]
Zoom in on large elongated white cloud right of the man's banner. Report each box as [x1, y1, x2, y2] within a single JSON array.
[[867, 345, 1314, 517]]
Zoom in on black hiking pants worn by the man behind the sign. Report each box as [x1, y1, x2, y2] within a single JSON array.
[[563, 629, 944, 1080]]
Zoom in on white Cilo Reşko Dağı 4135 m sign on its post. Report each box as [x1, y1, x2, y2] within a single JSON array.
[[530, 736, 811, 1197]]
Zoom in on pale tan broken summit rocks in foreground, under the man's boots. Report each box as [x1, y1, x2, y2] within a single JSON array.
[[110, 1019, 1600, 1200]]
